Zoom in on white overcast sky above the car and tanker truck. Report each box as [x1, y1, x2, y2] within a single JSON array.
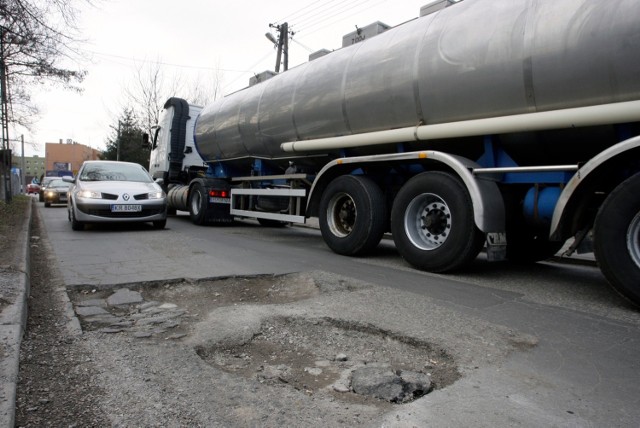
[[14, 0, 431, 156]]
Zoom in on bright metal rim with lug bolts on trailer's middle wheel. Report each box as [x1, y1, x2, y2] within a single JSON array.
[[404, 193, 451, 250]]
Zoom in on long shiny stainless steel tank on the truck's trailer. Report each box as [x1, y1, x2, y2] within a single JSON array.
[[195, 0, 640, 171]]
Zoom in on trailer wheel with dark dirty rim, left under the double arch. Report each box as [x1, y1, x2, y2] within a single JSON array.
[[319, 175, 387, 256]]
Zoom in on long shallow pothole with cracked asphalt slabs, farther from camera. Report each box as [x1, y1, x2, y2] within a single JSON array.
[[69, 273, 321, 339]]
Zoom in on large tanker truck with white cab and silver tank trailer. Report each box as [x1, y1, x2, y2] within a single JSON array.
[[150, 0, 640, 305]]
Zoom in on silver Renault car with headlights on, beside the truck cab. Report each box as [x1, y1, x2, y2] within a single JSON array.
[[63, 161, 167, 230]]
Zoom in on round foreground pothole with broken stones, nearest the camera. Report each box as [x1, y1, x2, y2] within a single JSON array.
[[196, 317, 460, 403]]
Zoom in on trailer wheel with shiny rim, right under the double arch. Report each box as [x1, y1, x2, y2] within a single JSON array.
[[391, 172, 484, 272]]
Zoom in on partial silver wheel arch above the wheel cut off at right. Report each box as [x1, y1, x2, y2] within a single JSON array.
[[549, 136, 640, 240]]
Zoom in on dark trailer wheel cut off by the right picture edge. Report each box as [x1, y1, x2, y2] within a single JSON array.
[[593, 173, 640, 306]]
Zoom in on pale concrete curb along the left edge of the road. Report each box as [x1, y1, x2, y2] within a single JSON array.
[[0, 196, 33, 427]]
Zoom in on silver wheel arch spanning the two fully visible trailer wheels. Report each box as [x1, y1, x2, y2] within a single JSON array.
[[306, 151, 505, 233]]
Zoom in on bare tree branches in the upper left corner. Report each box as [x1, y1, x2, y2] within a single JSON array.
[[0, 0, 90, 129]]
